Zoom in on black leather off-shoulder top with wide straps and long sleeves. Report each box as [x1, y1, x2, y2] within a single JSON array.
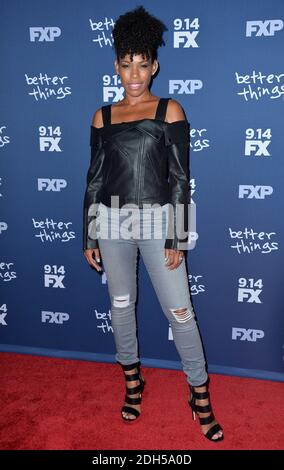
[[83, 98, 190, 250]]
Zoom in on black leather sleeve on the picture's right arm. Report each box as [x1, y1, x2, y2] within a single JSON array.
[[164, 119, 190, 250]]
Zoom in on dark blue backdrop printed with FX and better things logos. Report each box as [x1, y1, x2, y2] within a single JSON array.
[[0, 0, 284, 380]]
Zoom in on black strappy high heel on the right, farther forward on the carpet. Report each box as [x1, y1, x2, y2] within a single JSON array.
[[188, 381, 224, 442]]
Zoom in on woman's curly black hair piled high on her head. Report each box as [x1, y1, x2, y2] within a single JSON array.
[[112, 5, 168, 63]]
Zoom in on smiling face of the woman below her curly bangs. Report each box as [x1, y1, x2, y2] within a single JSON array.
[[114, 54, 158, 96]]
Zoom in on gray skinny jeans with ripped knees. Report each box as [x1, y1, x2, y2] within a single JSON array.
[[96, 203, 207, 386]]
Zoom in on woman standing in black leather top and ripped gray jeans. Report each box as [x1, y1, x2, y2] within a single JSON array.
[[83, 6, 223, 441]]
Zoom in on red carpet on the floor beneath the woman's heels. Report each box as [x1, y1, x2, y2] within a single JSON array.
[[0, 353, 284, 450]]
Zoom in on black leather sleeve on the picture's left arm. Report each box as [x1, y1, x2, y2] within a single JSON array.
[[83, 126, 105, 250]]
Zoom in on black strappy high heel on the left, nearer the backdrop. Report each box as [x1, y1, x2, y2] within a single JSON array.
[[120, 361, 146, 423]]
